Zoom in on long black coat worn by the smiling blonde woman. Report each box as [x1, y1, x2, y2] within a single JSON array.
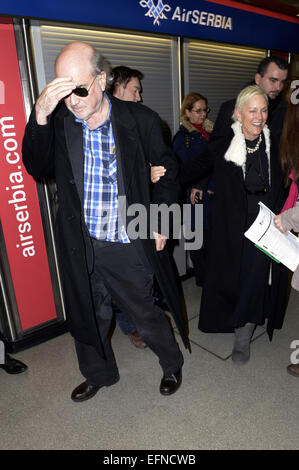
[[181, 130, 288, 339]]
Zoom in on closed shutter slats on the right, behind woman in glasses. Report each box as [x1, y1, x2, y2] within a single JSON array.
[[184, 40, 266, 120]]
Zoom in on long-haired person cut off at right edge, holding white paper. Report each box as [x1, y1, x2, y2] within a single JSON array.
[[274, 86, 299, 377]]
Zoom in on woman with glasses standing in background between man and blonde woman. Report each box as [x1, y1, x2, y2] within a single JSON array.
[[173, 93, 214, 286]]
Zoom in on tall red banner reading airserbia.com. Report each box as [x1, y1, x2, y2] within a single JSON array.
[[0, 20, 57, 330]]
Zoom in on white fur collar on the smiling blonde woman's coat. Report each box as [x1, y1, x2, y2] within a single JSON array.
[[224, 121, 270, 177]]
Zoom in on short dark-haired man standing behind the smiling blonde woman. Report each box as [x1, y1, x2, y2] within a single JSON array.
[[211, 56, 288, 141]]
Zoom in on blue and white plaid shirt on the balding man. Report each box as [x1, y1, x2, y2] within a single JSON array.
[[75, 94, 130, 243]]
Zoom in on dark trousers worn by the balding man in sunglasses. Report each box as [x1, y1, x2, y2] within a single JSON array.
[[75, 239, 183, 386]]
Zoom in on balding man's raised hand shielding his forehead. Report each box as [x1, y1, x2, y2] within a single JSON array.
[[35, 77, 77, 125]]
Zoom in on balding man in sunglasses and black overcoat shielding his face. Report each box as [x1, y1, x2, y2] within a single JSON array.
[[23, 42, 187, 402]]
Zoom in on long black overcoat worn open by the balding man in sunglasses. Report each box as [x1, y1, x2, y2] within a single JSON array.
[[23, 95, 187, 347]]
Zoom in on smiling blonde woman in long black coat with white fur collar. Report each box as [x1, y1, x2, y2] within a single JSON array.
[[181, 85, 287, 364]]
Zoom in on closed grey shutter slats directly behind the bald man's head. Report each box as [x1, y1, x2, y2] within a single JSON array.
[[35, 22, 177, 133]]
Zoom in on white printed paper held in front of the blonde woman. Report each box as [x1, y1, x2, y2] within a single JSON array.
[[244, 202, 299, 271]]
